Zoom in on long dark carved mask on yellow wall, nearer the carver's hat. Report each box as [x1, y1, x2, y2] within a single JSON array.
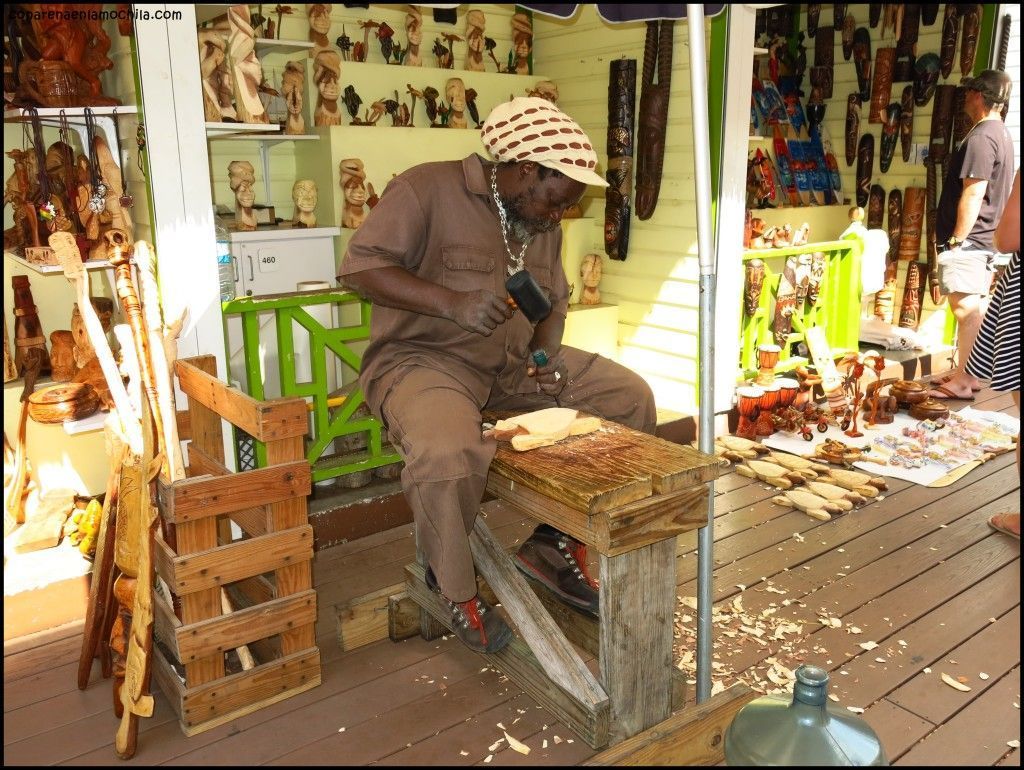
[[604, 58, 637, 260]]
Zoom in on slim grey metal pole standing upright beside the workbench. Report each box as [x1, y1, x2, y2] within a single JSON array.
[[686, 3, 717, 703]]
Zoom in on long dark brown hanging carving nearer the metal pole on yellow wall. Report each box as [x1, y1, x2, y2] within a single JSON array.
[[636, 19, 675, 220]]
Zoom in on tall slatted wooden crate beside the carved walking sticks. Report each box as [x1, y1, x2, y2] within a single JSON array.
[[153, 356, 321, 735]]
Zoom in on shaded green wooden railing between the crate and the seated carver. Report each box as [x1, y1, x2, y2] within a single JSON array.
[[222, 289, 401, 481]]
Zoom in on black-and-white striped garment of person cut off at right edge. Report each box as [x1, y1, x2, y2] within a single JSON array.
[[967, 251, 1021, 390]]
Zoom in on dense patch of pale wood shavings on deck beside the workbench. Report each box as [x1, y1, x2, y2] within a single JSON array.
[[674, 594, 827, 695]]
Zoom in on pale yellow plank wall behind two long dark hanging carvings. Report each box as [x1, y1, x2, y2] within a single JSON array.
[[534, 5, 708, 414]]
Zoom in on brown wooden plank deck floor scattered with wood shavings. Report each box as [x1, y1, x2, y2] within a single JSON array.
[[4, 392, 1021, 766]]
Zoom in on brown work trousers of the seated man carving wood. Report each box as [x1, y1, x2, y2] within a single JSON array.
[[370, 346, 656, 601]]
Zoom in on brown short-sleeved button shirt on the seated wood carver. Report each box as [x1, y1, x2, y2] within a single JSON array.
[[338, 155, 568, 409]]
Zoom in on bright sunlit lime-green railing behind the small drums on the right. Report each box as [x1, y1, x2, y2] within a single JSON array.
[[739, 230, 864, 378]]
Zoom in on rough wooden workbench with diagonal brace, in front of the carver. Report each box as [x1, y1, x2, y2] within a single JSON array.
[[407, 421, 720, 748]]
